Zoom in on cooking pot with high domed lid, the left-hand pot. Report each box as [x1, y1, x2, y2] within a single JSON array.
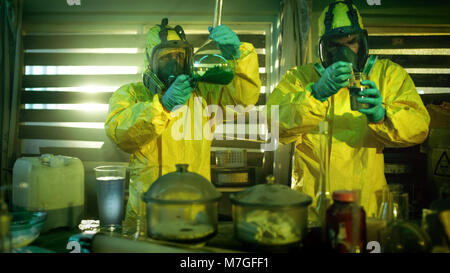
[[142, 164, 222, 242]]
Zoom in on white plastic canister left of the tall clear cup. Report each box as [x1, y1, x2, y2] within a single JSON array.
[[13, 154, 85, 231]]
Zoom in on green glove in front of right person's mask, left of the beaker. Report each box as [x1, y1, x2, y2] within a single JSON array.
[[312, 62, 352, 102]]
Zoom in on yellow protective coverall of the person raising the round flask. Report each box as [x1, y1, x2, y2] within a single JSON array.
[[105, 27, 261, 218]]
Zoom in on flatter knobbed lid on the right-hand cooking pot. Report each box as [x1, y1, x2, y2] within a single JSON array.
[[230, 178, 312, 206]]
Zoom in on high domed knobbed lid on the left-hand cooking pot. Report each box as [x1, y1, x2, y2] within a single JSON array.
[[143, 164, 222, 203]]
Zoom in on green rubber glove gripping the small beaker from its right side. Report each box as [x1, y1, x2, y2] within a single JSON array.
[[356, 80, 386, 123]]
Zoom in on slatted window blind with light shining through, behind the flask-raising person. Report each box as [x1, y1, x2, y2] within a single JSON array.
[[19, 31, 268, 161]]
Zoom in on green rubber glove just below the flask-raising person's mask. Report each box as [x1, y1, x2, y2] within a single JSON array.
[[161, 75, 193, 111]]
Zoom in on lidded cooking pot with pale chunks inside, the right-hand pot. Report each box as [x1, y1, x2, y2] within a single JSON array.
[[230, 177, 312, 247]]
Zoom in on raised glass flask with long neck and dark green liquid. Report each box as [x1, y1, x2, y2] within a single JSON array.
[[193, 0, 236, 85]]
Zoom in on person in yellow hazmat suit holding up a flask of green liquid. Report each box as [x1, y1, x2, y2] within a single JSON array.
[[105, 18, 261, 220]]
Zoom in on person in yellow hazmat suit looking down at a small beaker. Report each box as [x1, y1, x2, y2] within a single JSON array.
[[267, 1, 430, 217]]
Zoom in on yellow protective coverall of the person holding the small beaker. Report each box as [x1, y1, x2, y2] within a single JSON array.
[[267, 59, 430, 216]]
